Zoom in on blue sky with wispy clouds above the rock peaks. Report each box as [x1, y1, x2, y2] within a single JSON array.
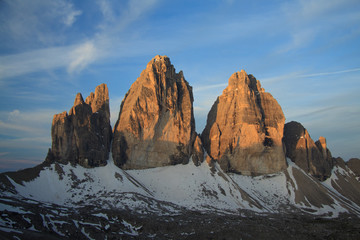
[[0, 0, 360, 171]]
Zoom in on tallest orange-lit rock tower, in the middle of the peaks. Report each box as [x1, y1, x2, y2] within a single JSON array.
[[112, 56, 196, 169]]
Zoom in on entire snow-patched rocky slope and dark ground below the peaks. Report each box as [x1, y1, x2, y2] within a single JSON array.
[[0, 160, 360, 239]]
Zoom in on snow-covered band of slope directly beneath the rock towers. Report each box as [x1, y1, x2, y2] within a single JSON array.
[[2, 157, 358, 217]]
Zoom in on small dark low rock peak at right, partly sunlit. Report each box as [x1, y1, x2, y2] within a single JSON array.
[[284, 122, 334, 181]]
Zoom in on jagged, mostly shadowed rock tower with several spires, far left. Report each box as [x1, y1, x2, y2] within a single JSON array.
[[46, 84, 112, 167]]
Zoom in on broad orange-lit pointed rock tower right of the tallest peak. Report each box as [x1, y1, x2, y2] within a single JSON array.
[[201, 70, 286, 175]]
